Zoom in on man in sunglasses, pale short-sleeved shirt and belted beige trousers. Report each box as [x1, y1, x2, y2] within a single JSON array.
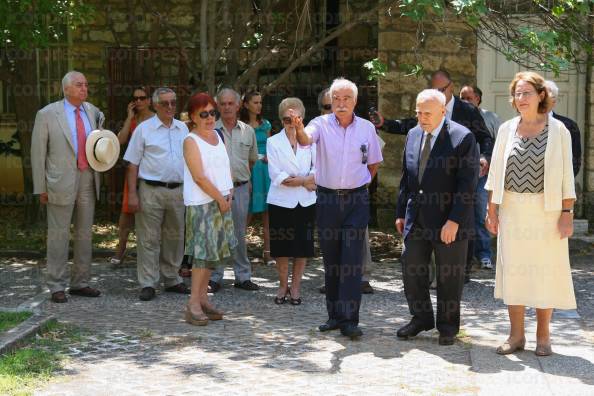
[[124, 88, 190, 301]]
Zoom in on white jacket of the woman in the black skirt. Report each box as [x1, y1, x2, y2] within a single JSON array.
[[266, 129, 316, 209]]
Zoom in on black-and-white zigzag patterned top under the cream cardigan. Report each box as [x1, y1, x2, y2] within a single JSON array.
[[505, 125, 549, 193]]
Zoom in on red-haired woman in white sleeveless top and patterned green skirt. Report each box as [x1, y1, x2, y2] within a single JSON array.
[[184, 93, 237, 326]]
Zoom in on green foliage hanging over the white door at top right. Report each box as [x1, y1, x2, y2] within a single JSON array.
[[376, 0, 594, 76]]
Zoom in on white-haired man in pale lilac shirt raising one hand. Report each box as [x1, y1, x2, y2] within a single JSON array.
[[292, 78, 383, 339]]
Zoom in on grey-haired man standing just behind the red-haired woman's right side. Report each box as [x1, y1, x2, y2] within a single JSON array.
[[208, 88, 260, 293]]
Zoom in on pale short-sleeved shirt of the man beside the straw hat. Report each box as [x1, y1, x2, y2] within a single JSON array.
[[124, 115, 188, 183]]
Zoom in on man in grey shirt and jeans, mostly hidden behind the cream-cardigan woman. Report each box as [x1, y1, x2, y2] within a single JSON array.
[[460, 85, 501, 269]]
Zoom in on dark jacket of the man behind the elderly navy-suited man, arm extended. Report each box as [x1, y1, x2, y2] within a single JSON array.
[[382, 96, 494, 159]]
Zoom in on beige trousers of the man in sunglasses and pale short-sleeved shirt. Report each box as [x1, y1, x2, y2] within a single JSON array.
[[136, 181, 185, 288]]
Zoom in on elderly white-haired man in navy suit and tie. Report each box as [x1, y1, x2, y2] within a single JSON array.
[[396, 89, 479, 345]]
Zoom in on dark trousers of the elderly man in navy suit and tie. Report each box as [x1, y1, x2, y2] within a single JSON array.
[[401, 225, 468, 336]]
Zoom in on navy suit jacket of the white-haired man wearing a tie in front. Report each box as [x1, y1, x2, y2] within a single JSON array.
[[396, 120, 479, 240]]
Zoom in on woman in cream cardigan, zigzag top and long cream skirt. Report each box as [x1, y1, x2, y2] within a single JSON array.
[[485, 72, 576, 356]]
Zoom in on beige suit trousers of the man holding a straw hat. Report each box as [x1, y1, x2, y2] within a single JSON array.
[[47, 169, 95, 293]]
